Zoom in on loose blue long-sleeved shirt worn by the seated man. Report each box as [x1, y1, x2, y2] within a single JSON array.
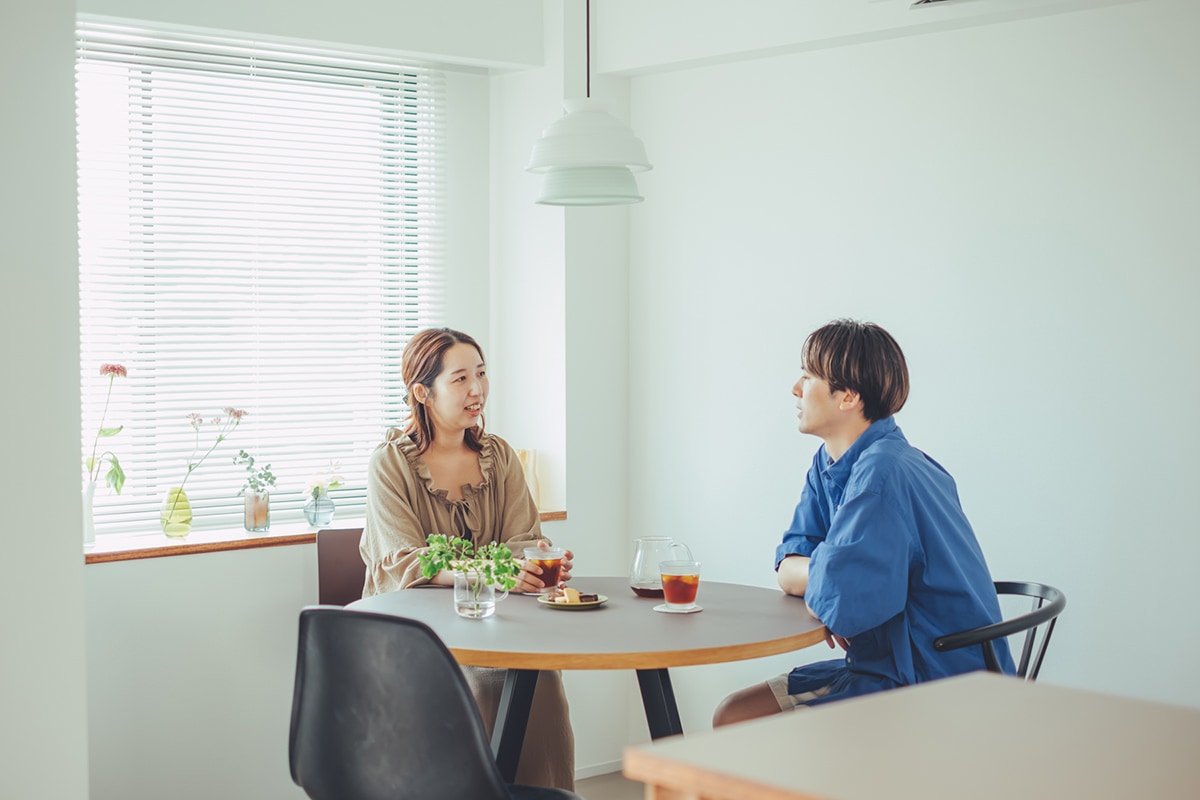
[[775, 417, 1015, 704]]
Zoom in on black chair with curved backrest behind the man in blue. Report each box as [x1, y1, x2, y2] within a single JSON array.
[[934, 581, 1067, 680]]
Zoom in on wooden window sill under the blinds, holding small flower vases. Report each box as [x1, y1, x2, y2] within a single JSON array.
[[84, 511, 566, 564]]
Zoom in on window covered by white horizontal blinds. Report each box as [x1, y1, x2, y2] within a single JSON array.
[[77, 18, 443, 534]]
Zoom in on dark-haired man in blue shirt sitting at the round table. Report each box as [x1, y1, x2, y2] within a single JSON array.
[[713, 320, 1013, 726]]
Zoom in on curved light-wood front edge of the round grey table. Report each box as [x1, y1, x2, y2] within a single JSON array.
[[450, 626, 826, 669]]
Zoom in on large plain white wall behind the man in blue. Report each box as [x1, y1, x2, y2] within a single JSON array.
[[624, 0, 1200, 727]]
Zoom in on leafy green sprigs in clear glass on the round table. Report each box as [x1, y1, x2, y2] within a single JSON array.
[[416, 534, 521, 619]]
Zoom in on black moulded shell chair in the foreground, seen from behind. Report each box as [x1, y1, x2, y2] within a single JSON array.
[[288, 606, 580, 800]]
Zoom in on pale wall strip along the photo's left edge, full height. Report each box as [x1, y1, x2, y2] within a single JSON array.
[[0, 2, 88, 800]]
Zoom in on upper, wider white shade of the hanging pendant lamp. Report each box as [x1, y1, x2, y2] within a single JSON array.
[[526, 98, 650, 173]]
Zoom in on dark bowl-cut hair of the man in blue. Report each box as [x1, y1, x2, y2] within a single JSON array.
[[802, 319, 908, 422]]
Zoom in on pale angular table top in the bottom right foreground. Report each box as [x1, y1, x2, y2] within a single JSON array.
[[624, 673, 1200, 800]]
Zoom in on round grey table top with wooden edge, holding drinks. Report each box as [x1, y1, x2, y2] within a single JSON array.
[[349, 577, 826, 669]]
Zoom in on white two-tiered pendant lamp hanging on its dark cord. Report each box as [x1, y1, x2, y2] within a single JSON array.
[[526, 0, 650, 205]]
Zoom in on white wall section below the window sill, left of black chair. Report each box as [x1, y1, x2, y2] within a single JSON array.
[[86, 546, 317, 800]]
